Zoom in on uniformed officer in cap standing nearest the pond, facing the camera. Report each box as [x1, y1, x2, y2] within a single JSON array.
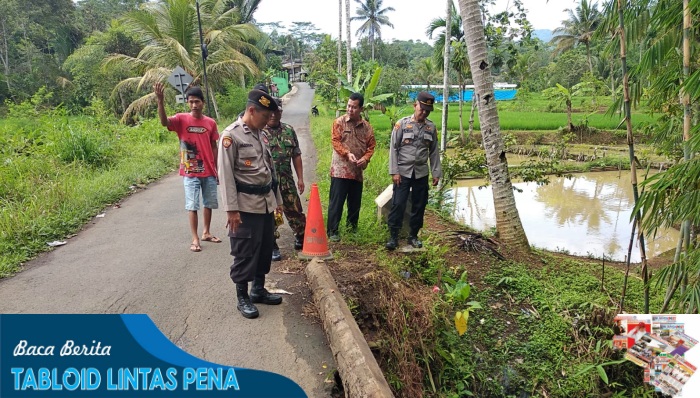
[[385, 91, 442, 250]]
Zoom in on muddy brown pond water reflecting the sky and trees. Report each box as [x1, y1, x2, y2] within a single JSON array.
[[452, 171, 678, 262]]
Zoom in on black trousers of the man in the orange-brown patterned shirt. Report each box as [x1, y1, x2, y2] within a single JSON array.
[[326, 177, 362, 235]]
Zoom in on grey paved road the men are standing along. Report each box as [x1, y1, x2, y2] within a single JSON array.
[[0, 83, 335, 397]]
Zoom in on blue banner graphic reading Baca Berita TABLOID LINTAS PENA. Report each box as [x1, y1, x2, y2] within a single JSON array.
[[0, 314, 306, 398]]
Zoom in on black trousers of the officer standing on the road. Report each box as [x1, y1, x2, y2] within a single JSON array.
[[229, 212, 275, 283]]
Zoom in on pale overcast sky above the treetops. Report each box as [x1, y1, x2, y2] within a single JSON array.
[[255, 0, 578, 42]]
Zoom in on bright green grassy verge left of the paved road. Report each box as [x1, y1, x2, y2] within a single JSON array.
[[0, 99, 177, 277]]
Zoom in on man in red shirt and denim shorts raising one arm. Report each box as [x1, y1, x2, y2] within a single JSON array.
[[153, 82, 221, 252]]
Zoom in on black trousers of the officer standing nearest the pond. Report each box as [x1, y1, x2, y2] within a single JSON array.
[[387, 176, 428, 236]]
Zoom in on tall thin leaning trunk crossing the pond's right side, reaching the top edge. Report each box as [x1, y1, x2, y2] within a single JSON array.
[[617, 0, 649, 314]]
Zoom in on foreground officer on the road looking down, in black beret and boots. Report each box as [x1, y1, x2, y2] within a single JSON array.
[[218, 90, 282, 318]]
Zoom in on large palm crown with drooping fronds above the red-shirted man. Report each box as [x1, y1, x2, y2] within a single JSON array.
[[104, 0, 264, 121]]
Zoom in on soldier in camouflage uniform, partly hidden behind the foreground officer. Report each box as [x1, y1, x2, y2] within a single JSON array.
[[265, 99, 306, 261]]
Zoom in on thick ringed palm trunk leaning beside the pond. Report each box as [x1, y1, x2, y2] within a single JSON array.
[[459, 0, 530, 251]]
